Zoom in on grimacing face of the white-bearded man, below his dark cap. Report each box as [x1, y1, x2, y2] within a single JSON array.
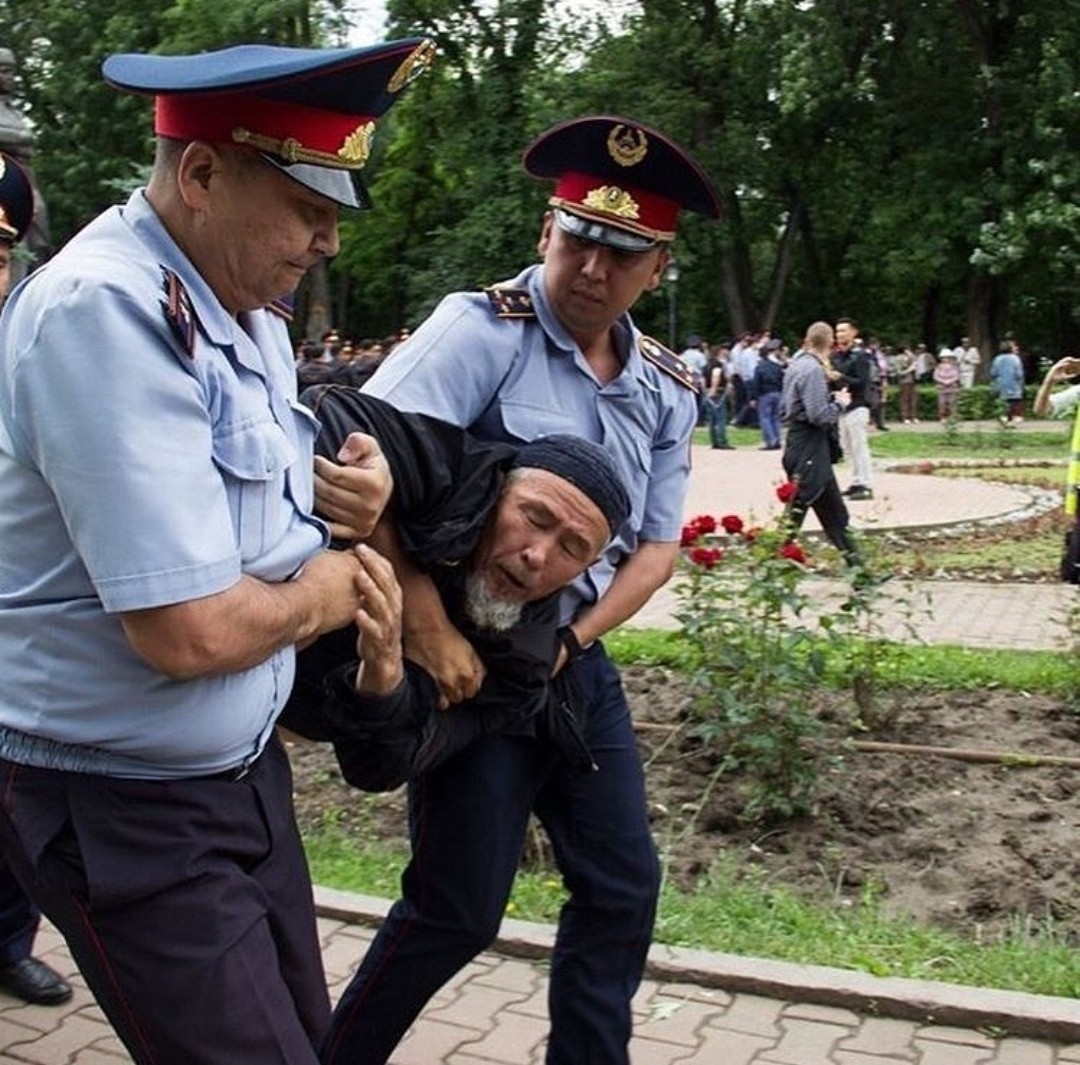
[[470, 468, 610, 629]]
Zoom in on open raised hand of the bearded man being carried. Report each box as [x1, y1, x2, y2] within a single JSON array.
[[353, 543, 405, 695]]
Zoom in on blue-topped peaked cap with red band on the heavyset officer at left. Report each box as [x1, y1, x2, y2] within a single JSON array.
[[102, 38, 434, 207]]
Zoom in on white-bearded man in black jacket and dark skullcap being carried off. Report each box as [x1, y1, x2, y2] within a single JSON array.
[[282, 387, 630, 791]]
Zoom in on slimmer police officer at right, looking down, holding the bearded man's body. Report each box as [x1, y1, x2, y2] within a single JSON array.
[[325, 116, 720, 1065]]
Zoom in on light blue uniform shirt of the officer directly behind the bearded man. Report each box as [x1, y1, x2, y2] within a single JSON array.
[[364, 266, 697, 622]]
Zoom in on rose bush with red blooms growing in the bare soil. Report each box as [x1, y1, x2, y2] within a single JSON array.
[[675, 482, 858, 821]]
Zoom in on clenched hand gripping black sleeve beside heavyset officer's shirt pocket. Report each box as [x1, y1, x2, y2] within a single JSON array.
[[315, 433, 394, 540]]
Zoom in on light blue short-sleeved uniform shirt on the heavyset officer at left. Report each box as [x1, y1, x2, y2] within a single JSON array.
[[0, 191, 327, 778]]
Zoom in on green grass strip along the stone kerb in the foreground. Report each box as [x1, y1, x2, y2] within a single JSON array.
[[305, 812, 1080, 998]]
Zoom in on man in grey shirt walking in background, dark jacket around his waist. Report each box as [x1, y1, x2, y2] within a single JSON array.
[[781, 322, 863, 570]]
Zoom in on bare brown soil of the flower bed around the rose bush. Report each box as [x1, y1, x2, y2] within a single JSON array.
[[291, 666, 1080, 939]]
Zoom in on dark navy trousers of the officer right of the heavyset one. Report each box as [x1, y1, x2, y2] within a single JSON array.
[[323, 645, 660, 1065]]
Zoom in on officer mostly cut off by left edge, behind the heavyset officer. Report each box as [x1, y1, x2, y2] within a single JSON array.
[[0, 152, 71, 1006]]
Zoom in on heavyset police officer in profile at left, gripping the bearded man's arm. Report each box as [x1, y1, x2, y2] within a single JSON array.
[[0, 40, 428, 1065]]
